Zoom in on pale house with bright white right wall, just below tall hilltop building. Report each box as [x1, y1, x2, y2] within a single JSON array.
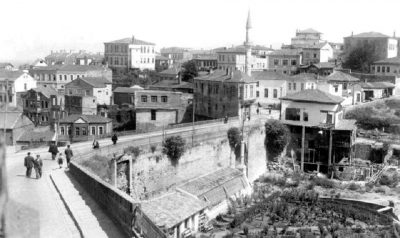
[[302, 42, 333, 64]]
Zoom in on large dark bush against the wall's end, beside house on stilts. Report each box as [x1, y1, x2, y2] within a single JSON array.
[[264, 120, 290, 163]]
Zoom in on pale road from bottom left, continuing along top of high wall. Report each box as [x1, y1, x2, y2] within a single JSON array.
[[6, 110, 277, 238]]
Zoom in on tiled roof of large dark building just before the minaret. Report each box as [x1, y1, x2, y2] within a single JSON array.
[[196, 70, 256, 82]]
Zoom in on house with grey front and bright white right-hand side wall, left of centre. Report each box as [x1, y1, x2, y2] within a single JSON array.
[[65, 77, 112, 105]]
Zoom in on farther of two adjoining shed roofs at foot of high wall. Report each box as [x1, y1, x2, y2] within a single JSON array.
[[179, 168, 249, 205]]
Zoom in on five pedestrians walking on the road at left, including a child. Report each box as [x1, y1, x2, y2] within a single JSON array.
[[24, 143, 74, 179]]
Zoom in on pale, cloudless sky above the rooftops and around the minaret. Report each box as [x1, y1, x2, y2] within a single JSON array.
[[0, 0, 400, 64]]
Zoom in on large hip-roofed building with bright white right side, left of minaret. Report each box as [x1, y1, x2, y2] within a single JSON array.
[[104, 36, 156, 70]]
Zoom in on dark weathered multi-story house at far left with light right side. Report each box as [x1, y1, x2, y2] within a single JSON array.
[[21, 87, 64, 126]]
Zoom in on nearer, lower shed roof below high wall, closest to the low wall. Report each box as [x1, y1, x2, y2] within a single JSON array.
[[140, 191, 207, 229]]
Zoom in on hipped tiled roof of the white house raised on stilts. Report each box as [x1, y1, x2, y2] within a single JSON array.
[[281, 89, 344, 104]]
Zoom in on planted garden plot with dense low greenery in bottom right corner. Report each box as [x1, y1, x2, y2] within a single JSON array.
[[209, 189, 397, 237]]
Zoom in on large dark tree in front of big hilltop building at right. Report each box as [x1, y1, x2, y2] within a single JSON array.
[[343, 43, 379, 73]]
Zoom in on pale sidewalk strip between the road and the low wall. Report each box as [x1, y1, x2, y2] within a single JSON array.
[[50, 169, 126, 238]]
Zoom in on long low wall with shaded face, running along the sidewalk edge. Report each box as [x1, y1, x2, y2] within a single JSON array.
[[70, 161, 166, 238]]
